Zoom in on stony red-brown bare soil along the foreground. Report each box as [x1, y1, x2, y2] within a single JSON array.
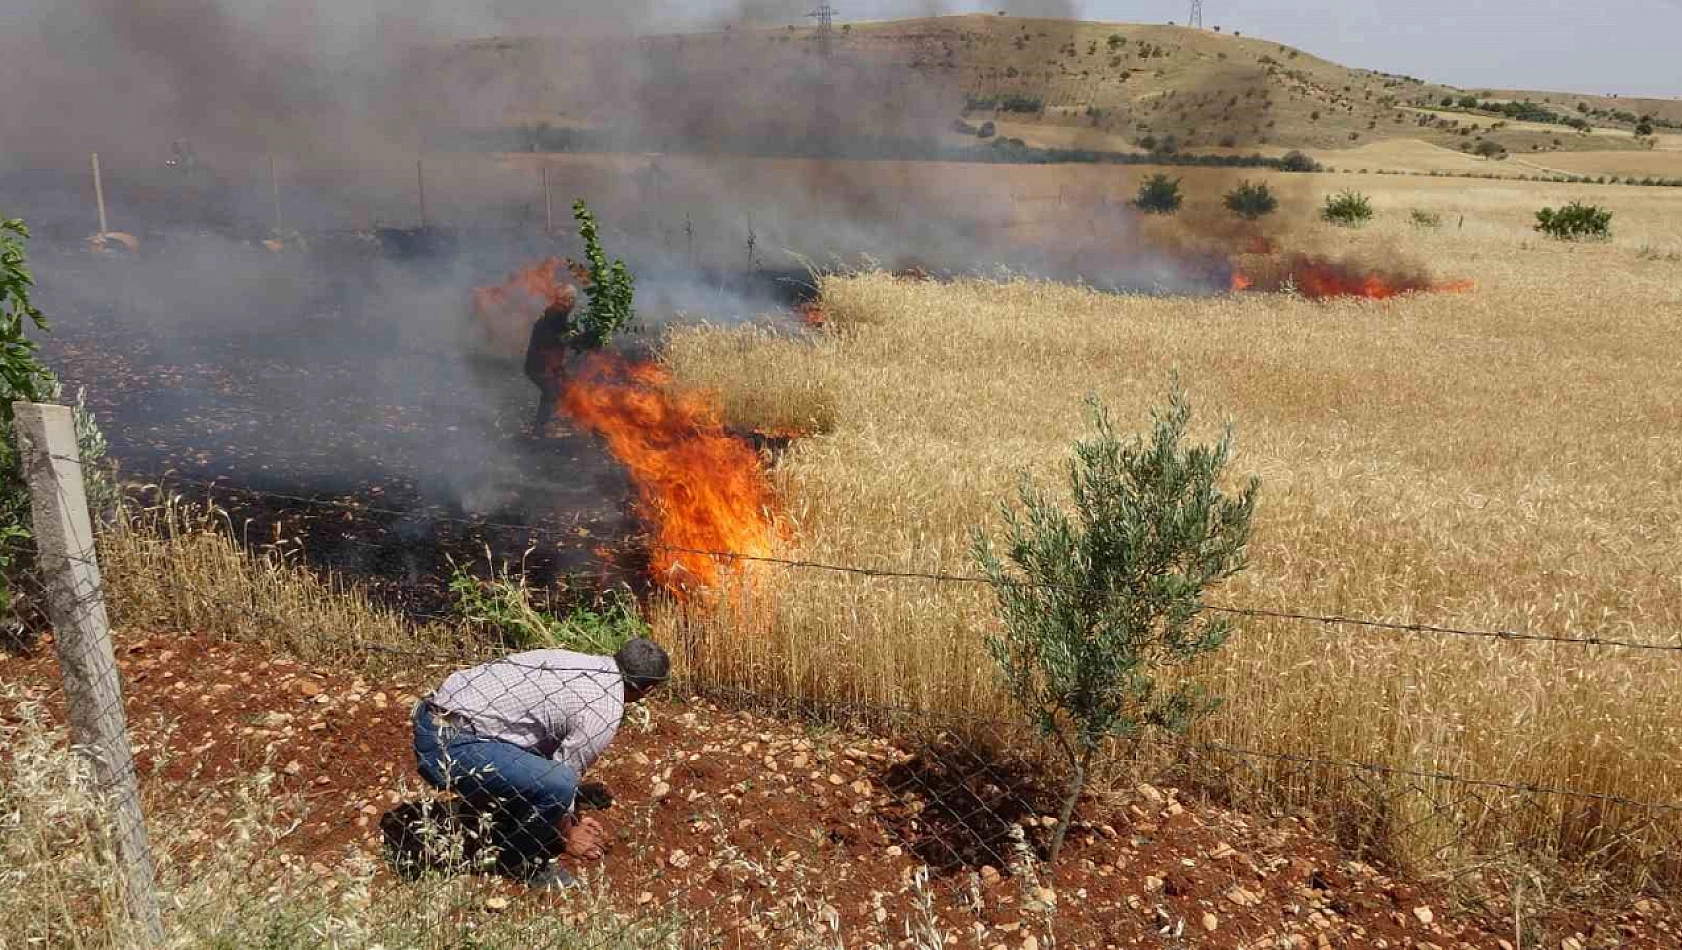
[[0, 634, 1682, 950]]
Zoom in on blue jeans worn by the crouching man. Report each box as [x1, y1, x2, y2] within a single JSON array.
[[414, 699, 579, 863]]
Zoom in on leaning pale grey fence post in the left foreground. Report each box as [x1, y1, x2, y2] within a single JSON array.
[[13, 402, 163, 942]]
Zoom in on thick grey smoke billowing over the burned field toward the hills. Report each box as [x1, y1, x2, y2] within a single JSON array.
[[0, 0, 1196, 585]]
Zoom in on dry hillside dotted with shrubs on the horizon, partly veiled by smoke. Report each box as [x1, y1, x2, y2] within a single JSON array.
[[429, 15, 1682, 162]]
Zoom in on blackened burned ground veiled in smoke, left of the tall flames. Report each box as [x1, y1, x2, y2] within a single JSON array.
[[35, 232, 799, 614]]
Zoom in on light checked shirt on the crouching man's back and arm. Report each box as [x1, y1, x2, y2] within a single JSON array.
[[431, 649, 626, 775]]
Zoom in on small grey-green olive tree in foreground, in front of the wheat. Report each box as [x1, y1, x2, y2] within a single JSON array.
[[974, 382, 1258, 863]]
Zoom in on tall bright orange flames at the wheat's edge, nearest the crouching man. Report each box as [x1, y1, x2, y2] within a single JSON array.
[[562, 355, 777, 599]]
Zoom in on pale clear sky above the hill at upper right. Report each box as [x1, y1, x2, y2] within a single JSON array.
[[793, 0, 1682, 98]]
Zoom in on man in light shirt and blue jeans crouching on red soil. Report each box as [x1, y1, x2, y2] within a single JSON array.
[[414, 639, 671, 889]]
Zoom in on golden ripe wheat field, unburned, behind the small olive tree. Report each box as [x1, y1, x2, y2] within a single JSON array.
[[663, 177, 1682, 874]]
